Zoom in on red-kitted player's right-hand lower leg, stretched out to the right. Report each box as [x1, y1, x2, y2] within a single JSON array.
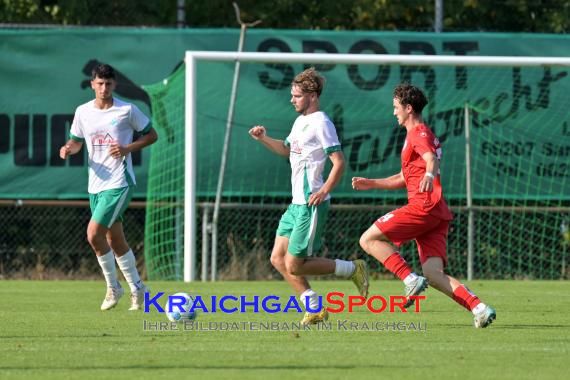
[[422, 257, 497, 328]]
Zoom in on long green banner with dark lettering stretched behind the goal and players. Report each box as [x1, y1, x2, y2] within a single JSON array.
[[0, 29, 570, 200]]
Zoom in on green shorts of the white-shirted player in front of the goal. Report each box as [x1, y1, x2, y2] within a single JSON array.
[[277, 201, 330, 257]]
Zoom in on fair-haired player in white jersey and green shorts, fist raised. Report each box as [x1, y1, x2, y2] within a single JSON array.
[[249, 68, 368, 324]]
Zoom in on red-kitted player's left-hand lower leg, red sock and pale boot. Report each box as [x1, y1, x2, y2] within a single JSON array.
[[360, 225, 428, 308]]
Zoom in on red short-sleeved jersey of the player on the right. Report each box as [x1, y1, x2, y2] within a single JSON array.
[[402, 124, 453, 220]]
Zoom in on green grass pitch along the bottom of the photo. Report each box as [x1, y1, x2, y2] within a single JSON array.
[[0, 281, 570, 380]]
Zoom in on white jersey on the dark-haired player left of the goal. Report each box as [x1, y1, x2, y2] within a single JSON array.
[[71, 98, 150, 194]]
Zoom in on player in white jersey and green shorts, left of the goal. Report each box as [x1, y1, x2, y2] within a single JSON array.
[[59, 64, 157, 310]]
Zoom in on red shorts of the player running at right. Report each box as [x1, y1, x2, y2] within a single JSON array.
[[374, 206, 449, 268]]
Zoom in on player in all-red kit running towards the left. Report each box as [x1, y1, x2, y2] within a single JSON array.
[[352, 84, 497, 328]]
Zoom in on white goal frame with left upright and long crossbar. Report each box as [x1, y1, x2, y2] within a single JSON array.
[[184, 51, 570, 282]]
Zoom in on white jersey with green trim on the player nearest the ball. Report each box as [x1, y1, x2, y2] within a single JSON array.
[[284, 111, 340, 205]]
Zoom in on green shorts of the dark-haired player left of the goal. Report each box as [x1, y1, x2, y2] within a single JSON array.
[[89, 186, 134, 228]]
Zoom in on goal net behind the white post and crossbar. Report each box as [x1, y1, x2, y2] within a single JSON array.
[[145, 52, 570, 280]]
